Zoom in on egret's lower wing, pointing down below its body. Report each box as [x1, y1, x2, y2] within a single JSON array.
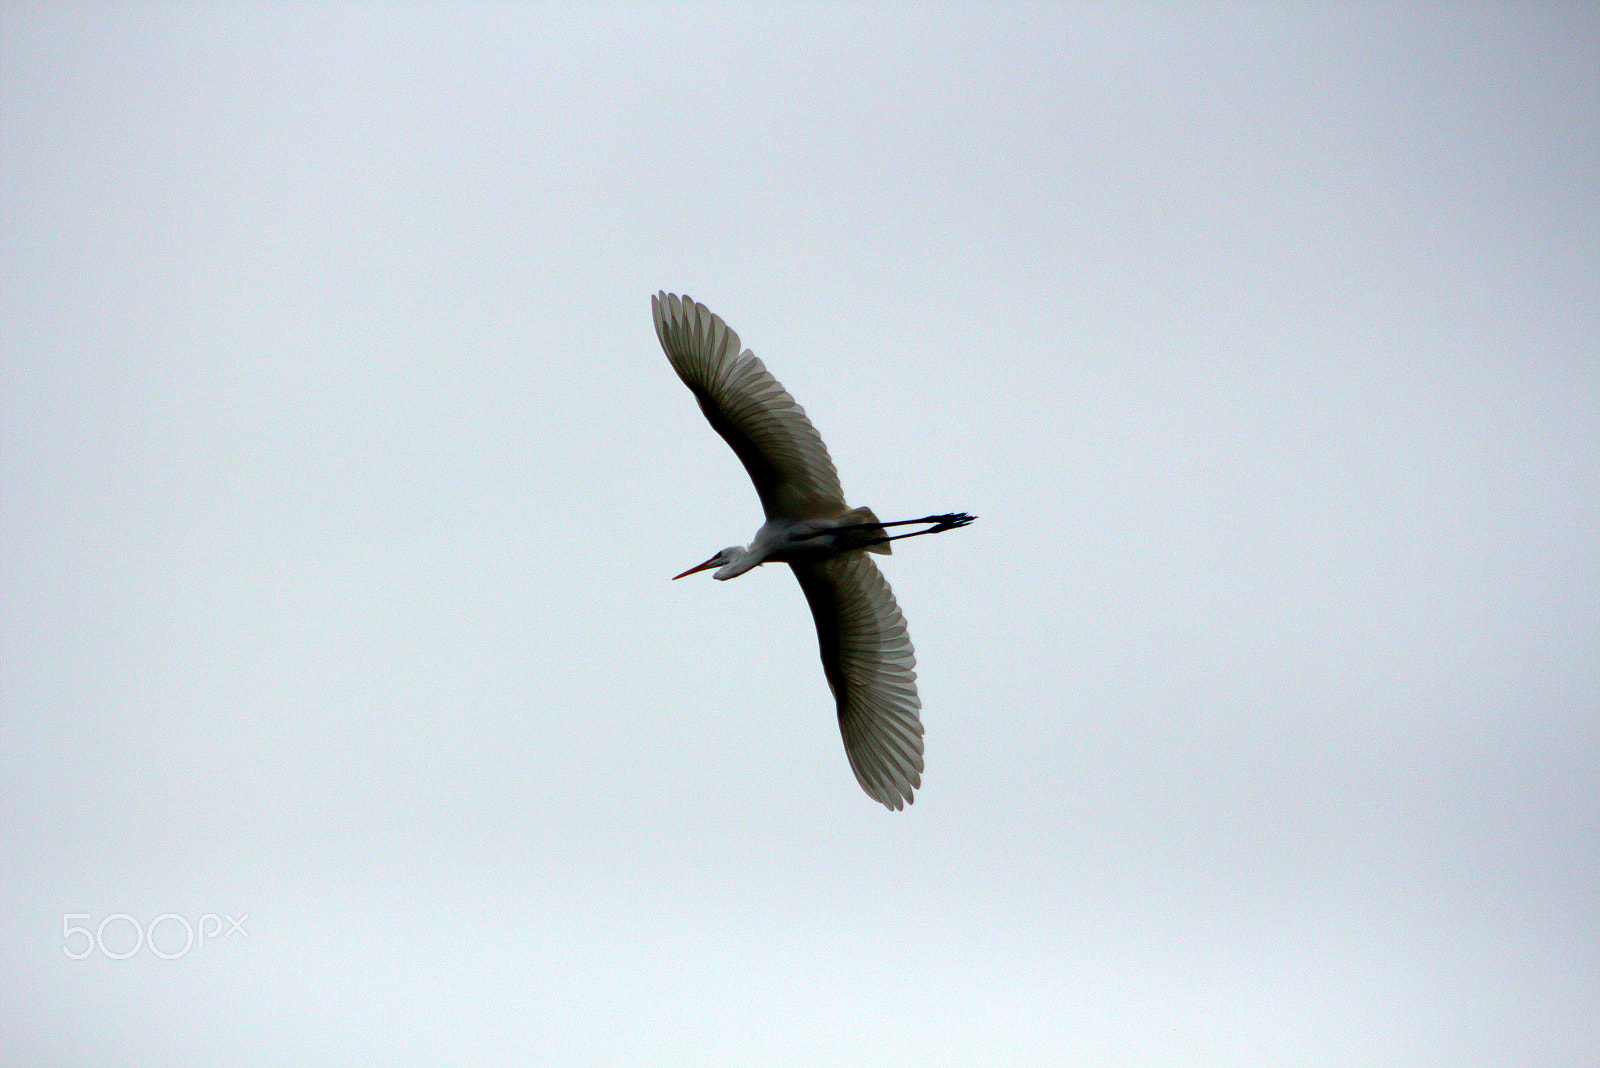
[[789, 550, 922, 809]]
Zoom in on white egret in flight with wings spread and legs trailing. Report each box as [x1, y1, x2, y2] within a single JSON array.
[[650, 293, 976, 809]]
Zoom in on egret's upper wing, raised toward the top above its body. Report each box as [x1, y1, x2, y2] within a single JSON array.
[[650, 293, 845, 518]]
